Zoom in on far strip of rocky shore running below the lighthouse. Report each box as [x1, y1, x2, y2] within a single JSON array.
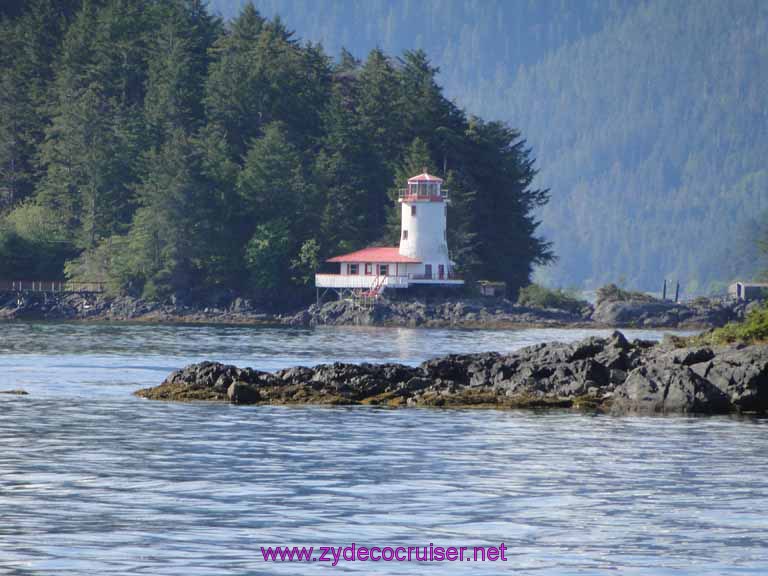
[[0, 292, 748, 329]]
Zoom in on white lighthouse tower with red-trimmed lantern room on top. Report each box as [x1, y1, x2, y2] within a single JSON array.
[[398, 171, 451, 280]]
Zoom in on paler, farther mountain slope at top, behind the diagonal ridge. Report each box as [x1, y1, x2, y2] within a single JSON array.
[[209, 0, 637, 113]]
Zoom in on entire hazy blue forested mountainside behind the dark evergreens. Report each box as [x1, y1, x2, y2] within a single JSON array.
[[206, 0, 768, 292]]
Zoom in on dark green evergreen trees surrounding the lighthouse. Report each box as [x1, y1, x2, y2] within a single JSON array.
[[0, 0, 553, 301]]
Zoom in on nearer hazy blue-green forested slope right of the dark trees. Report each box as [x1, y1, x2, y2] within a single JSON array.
[[504, 0, 768, 291]]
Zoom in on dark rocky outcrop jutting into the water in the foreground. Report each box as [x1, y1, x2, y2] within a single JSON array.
[[136, 332, 768, 414]]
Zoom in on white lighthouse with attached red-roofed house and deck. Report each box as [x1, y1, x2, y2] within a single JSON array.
[[315, 172, 464, 297]]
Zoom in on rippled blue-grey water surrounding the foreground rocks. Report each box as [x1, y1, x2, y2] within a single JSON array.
[[0, 324, 768, 576]]
